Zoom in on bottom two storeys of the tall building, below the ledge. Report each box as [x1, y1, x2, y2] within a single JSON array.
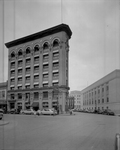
[[7, 86, 68, 112]]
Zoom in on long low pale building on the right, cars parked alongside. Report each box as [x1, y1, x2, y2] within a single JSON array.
[[81, 70, 120, 113]]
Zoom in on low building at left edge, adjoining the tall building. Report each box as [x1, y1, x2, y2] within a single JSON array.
[[0, 82, 7, 110]]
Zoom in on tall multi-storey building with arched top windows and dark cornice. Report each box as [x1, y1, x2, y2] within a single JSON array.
[[5, 24, 72, 111]]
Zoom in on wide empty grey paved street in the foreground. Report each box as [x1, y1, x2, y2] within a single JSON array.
[[0, 112, 120, 150]]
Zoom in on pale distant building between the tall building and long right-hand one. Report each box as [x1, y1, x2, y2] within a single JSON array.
[[69, 91, 81, 109]]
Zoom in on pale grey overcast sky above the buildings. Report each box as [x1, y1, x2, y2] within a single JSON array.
[[0, 0, 120, 91]]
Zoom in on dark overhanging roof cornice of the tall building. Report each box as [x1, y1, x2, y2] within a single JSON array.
[[5, 24, 72, 48]]
